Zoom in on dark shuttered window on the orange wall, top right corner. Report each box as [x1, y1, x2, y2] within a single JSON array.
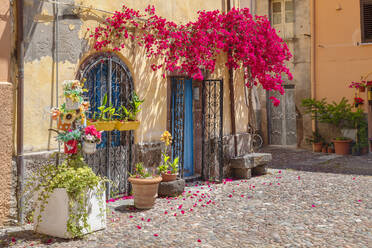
[[360, 0, 372, 43]]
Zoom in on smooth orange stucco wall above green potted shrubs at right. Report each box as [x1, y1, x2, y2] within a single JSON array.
[[315, 0, 372, 108]]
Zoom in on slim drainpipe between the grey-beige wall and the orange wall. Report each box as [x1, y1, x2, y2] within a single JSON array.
[[311, 0, 317, 131]]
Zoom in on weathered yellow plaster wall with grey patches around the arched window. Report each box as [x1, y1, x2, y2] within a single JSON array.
[[25, 0, 251, 152]]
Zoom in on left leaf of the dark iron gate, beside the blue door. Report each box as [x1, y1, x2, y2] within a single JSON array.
[[171, 77, 186, 178]]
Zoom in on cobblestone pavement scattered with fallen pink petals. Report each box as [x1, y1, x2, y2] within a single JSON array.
[[0, 148, 372, 247]]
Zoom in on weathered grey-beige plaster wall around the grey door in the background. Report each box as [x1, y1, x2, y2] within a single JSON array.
[[254, 0, 310, 146]]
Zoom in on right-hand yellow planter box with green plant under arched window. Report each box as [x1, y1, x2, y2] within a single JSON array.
[[116, 92, 144, 131]]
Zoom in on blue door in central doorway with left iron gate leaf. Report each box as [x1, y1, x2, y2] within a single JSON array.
[[172, 78, 194, 177]]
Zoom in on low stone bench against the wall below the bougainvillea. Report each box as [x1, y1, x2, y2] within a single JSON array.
[[230, 153, 272, 179]]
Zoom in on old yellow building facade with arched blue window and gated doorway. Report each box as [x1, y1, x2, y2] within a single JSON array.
[[0, 0, 256, 225]]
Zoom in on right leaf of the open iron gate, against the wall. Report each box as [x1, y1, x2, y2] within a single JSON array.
[[202, 80, 223, 181]]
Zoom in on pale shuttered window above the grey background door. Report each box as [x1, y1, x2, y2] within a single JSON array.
[[271, 0, 294, 39]]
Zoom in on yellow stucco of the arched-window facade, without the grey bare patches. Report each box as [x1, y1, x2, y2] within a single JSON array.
[[25, 0, 247, 152]]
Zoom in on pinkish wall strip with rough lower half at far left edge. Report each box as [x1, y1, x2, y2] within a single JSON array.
[[0, 1, 14, 226]]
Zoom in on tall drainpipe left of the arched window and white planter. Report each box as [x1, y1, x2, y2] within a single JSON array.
[[16, 0, 24, 224]]
